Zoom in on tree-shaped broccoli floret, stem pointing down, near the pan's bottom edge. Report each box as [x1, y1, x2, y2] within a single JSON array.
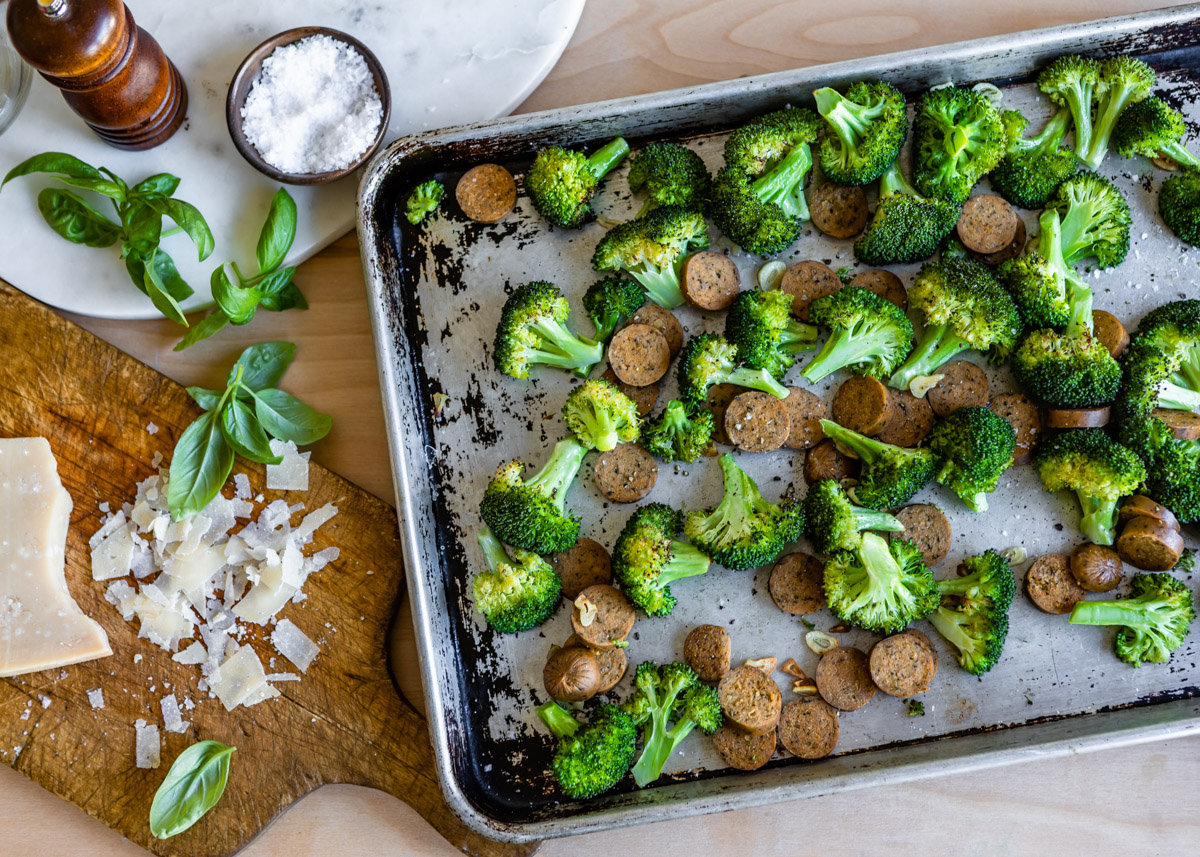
[[624, 661, 725, 787]]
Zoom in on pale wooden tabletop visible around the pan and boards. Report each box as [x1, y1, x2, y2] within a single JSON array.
[[0, 0, 1200, 857]]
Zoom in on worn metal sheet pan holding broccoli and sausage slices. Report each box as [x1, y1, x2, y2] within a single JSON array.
[[359, 6, 1200, 841]]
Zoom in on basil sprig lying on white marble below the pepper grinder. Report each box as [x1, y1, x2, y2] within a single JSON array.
[[0, 151, 214, 326]]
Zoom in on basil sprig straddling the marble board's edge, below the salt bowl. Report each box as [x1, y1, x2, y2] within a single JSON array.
[[175, 187, 308, 352]]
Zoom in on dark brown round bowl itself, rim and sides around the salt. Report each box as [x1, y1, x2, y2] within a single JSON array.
[[226, 26, 391, 185]]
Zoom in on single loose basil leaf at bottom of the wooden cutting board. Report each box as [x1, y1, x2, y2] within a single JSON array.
[[150, 741, 238, 839]]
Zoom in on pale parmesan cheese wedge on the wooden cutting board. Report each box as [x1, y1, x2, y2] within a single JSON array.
[[0, 437, 113, 677]]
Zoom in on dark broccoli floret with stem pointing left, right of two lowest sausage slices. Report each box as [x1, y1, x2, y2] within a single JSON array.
[[929, 550, 1016, 676]]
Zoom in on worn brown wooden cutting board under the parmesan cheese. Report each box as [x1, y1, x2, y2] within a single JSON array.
[[0, 282, 536, 857]]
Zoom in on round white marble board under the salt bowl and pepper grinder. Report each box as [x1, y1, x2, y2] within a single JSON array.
[[0, 0, 584, 319]]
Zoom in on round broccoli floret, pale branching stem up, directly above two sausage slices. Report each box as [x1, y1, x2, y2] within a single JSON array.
[[824, 533, 938, 634]]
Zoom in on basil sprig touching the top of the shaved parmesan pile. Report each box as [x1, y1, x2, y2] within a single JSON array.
[[167, 342, 334, 521]]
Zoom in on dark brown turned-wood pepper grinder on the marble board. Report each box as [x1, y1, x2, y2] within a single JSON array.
[[7, 0, 187, 149]]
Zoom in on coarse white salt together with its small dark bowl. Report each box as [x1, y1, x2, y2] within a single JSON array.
[[226, 26, 391, 185]]
